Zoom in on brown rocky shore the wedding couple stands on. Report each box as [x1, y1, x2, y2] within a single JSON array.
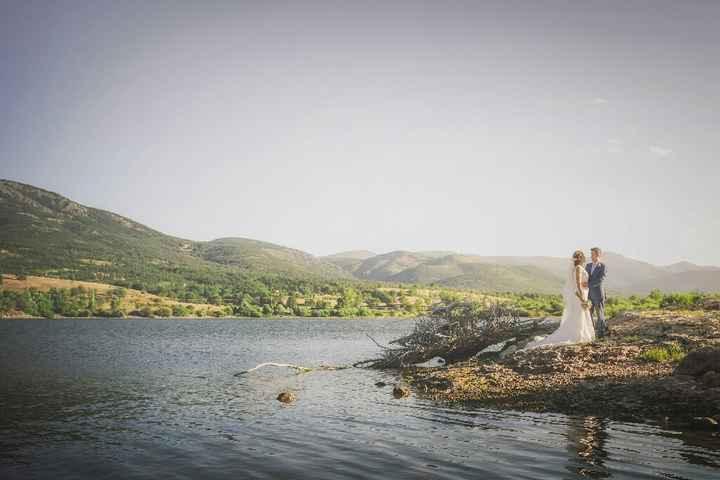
[[404, 310, 720, 428]]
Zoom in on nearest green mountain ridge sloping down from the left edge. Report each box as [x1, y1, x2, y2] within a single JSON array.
[[0, 180, 350, 282]]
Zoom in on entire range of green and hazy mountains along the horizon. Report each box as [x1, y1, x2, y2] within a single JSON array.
[[0, 180, 720, 299]]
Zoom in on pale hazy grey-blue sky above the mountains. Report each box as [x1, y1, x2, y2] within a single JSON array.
[[0, 0, 720, 265]]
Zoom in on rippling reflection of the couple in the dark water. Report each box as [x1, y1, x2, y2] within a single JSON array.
[[565, 417, 610, 478]]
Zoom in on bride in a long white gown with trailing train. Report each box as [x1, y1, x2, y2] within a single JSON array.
[[523, 250, 595, 350]]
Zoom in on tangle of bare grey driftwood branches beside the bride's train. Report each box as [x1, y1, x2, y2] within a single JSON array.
[[355, 302, 548, 369]]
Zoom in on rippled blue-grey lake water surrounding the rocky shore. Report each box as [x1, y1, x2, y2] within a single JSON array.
[[0, 319, 720, 479]]
